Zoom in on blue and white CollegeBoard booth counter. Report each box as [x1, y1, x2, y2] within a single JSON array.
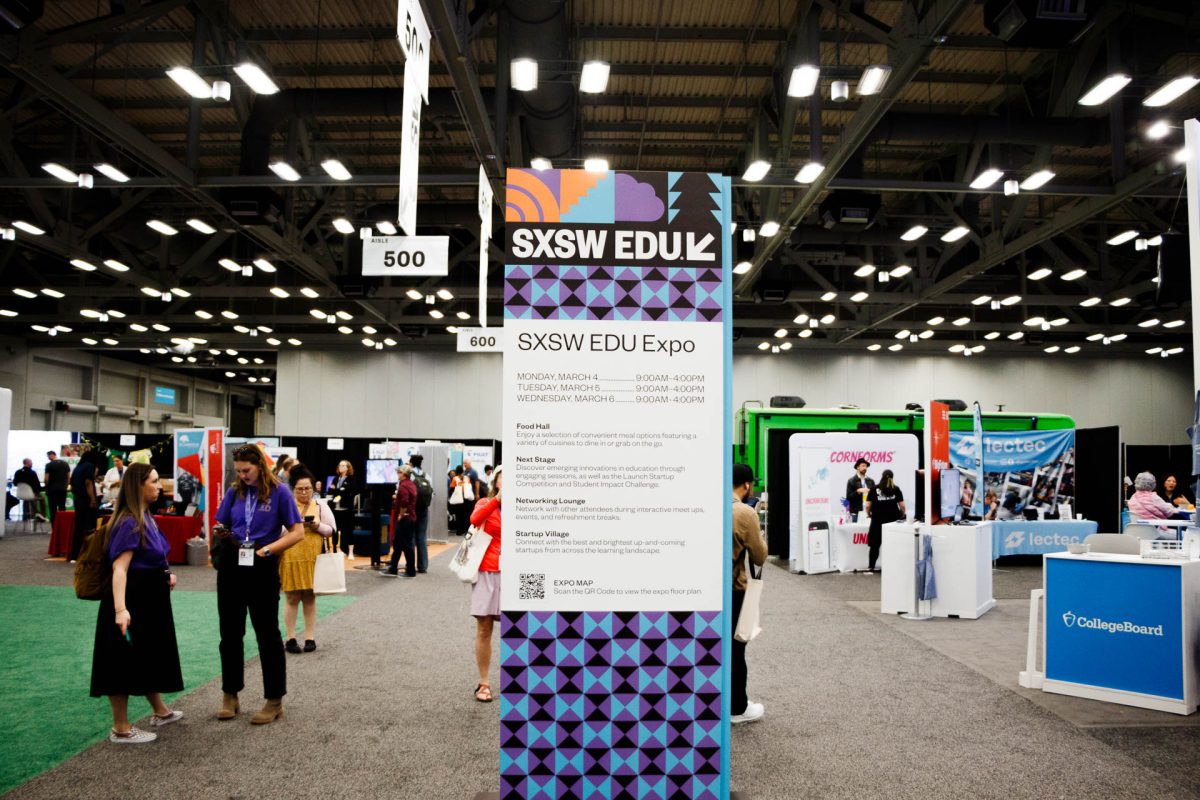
[[1043, 553, 1200, 715]]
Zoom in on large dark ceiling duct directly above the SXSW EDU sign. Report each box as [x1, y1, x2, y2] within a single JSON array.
[[499, 0, 577, 161]]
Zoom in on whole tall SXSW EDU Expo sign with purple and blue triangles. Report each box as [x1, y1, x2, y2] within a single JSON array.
[[500, 169, 732, 800]]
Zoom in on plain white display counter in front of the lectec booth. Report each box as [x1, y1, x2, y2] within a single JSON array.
[[880, 522, 996, 619]]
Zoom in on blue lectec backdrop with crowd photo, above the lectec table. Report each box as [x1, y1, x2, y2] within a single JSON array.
[[950, 429, 1075, 519]]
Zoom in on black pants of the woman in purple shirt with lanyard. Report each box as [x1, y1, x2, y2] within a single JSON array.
[[217, 554, 288, 700]]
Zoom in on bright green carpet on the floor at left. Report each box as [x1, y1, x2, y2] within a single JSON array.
[[0, 585, 354, 794]]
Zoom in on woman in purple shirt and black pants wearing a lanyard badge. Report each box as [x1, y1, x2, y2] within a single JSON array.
[[212, 445, 304, 724]]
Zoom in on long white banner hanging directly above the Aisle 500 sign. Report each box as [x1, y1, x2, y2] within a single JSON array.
[[396, 0, 430, 236]]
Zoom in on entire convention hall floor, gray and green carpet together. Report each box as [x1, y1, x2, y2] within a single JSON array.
[[0, 525, 1200, 800]]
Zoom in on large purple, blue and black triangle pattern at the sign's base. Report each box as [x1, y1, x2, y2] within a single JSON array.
[[500, 612, 722, 800]]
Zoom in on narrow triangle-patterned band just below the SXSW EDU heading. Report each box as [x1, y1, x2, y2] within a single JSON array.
[[504, 264, 725, 323]]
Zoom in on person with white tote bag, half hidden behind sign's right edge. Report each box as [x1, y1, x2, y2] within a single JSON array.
[[730, 464, 767, 724]]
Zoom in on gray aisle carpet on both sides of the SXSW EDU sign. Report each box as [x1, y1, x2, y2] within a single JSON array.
[[0, 527, 1200, 800]]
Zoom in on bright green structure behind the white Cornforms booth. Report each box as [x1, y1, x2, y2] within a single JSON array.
[[733, 405, 1075, 558]]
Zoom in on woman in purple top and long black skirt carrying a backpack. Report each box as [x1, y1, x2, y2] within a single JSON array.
[[91, 464, 184, 745]]
